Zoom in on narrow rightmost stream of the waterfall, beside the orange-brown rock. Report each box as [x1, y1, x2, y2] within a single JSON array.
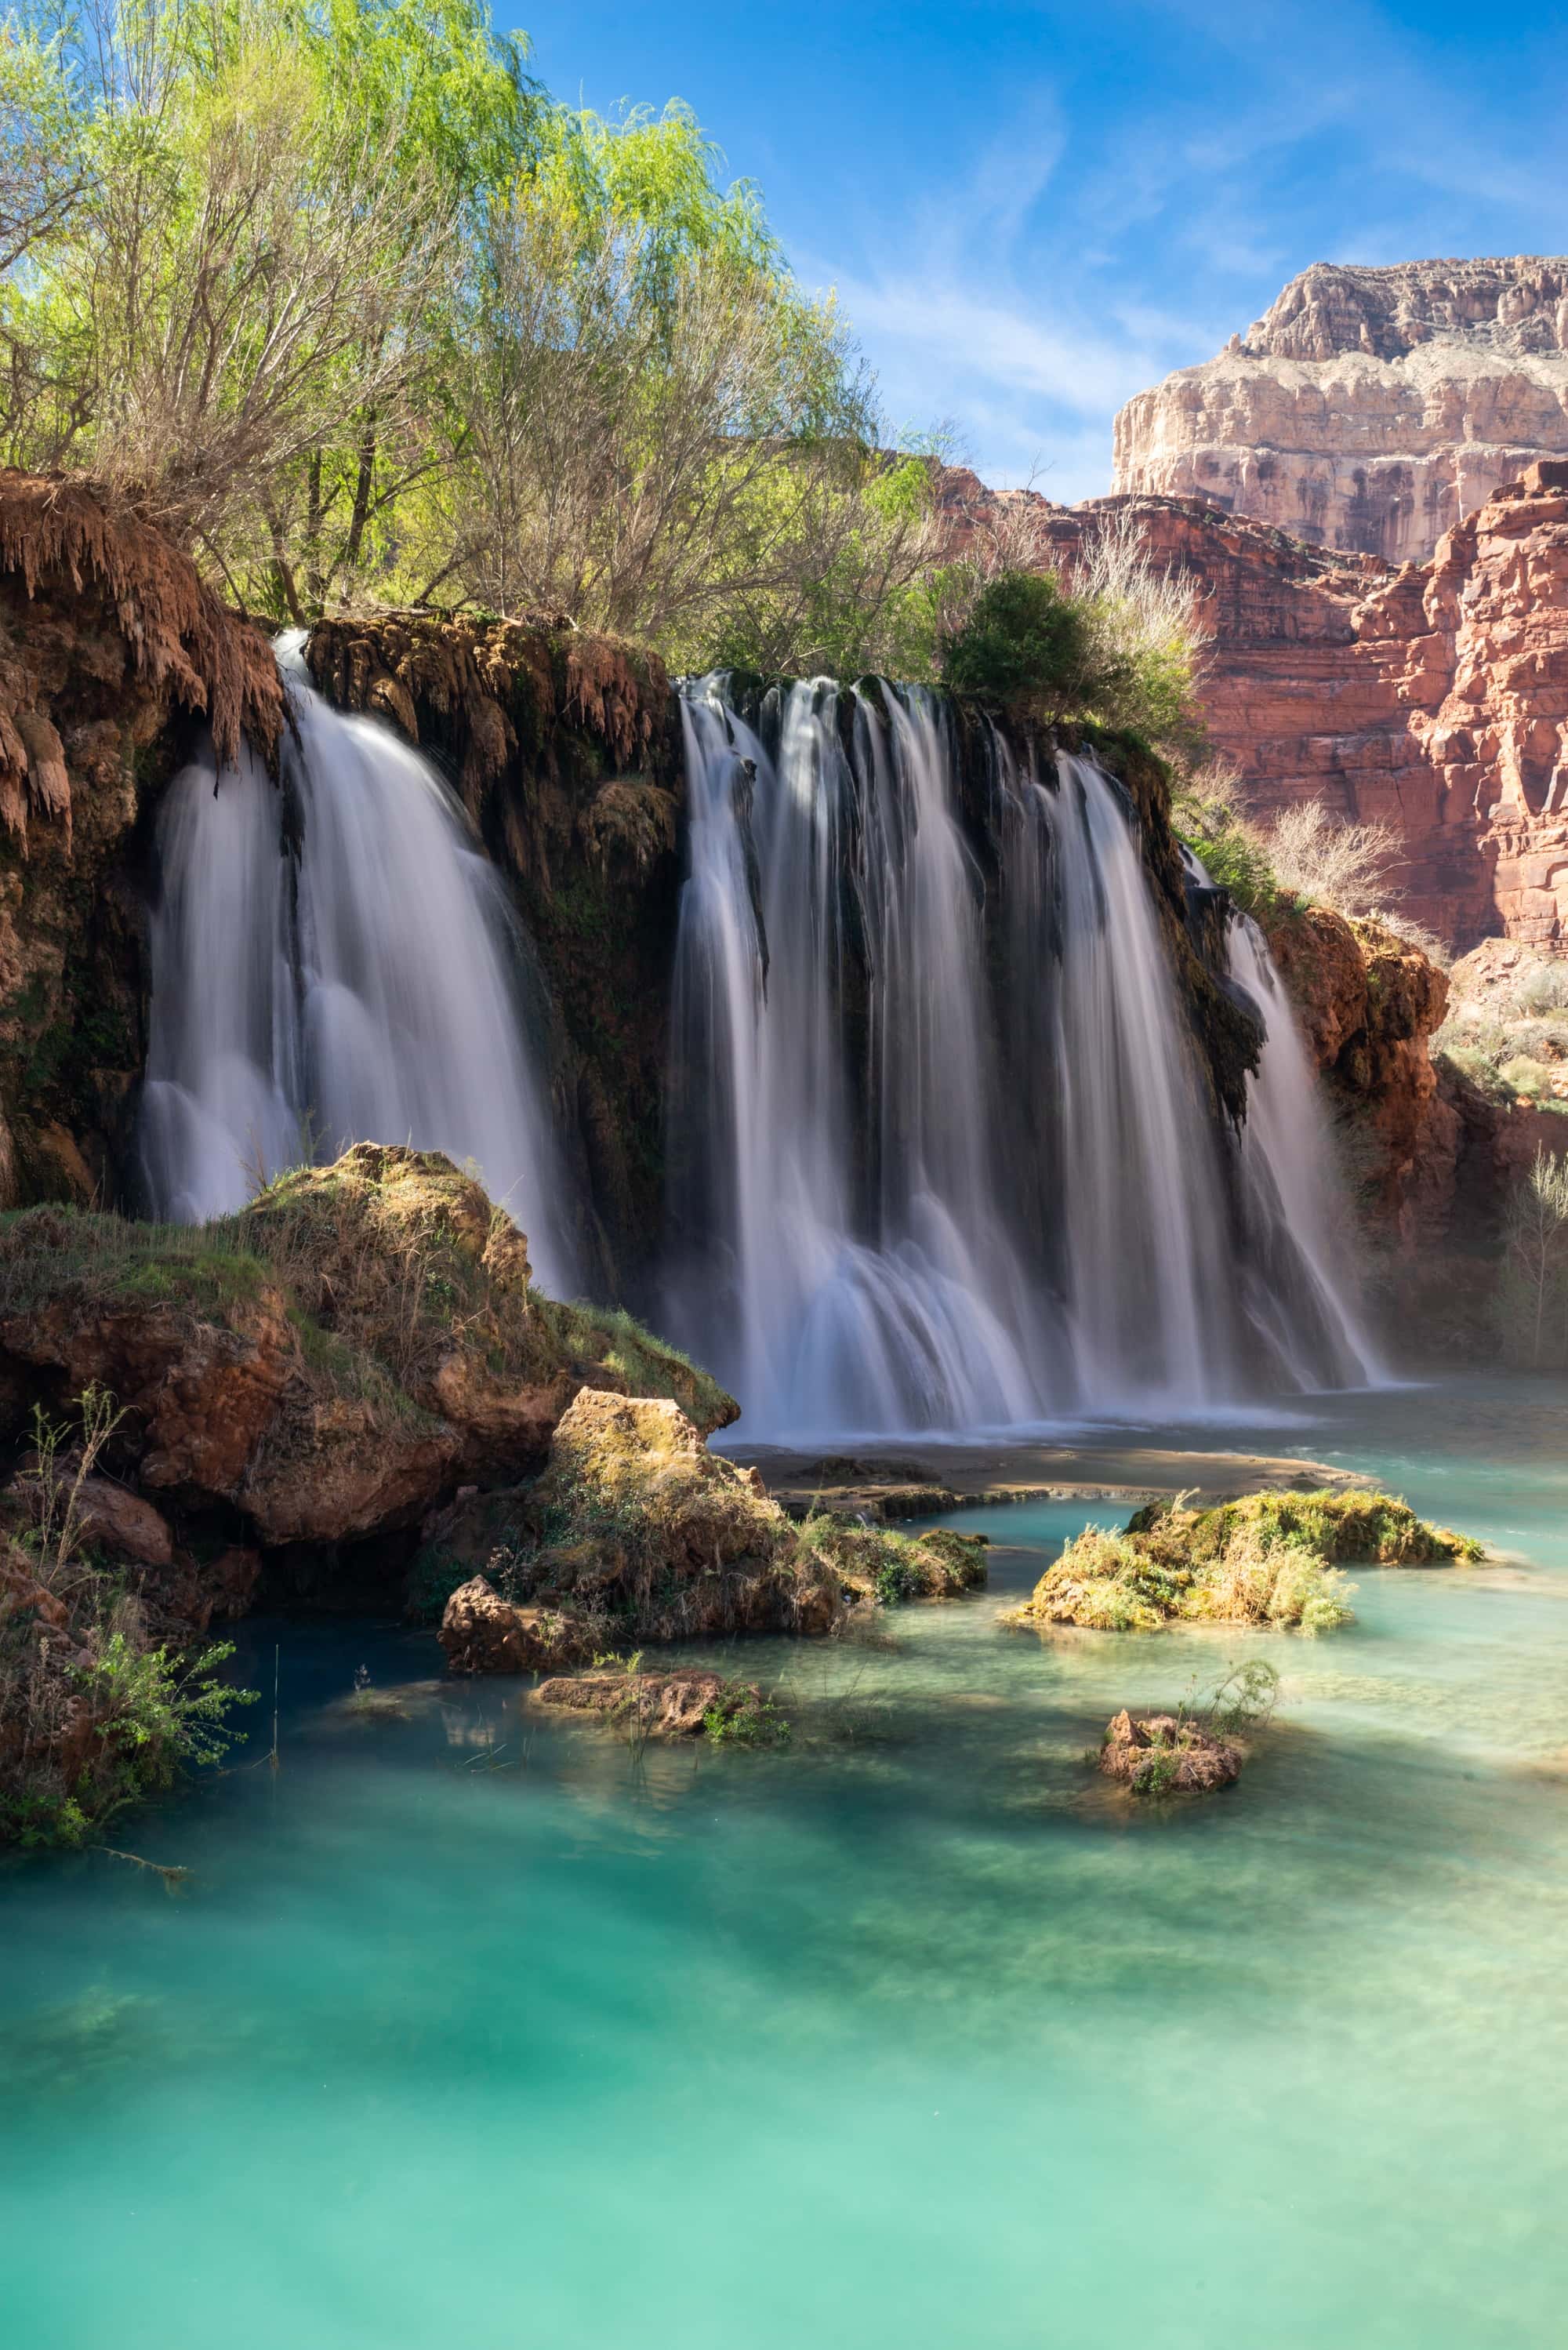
[[1227, 914, 1382, 1386]]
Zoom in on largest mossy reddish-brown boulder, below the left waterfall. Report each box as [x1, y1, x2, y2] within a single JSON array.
[[0, 1142, 736, 1549]]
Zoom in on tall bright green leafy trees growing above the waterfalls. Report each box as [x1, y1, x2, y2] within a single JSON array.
[[0, 0, 931, 667]]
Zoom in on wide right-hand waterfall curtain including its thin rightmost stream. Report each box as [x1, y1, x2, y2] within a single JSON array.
[[670, 677, 1368, 1433]]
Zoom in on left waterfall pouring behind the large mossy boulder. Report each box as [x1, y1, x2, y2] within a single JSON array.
[[141, 639, 572, 1290]]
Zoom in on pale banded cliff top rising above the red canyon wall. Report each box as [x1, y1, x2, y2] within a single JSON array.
[[1114, 256, 1568, 564]]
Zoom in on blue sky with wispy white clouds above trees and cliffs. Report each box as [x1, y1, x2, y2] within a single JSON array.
[[517, 0, 1568, 498]]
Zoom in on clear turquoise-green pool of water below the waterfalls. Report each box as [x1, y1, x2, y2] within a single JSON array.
[[0, 1386, 1568, 2350]]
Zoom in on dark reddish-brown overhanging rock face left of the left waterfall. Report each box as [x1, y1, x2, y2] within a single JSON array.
[[0, 467, 282, 1208]]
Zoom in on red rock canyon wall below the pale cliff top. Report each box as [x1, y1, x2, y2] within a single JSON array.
[[968, 460, 1568, 952]]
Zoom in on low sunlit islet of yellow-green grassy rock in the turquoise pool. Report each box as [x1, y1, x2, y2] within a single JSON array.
[[1006, 1492, 1483, 1633]]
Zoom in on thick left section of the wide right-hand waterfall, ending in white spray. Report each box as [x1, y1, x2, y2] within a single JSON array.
[[670, 681, 1036, 1426]]
